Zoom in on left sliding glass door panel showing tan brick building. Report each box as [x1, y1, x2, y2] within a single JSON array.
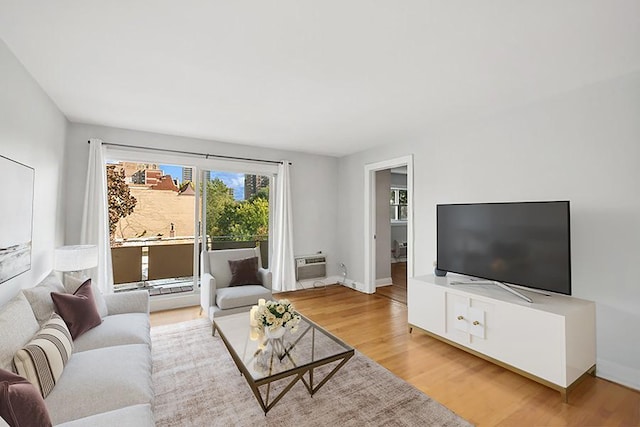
[[106, 160, 196, 296]]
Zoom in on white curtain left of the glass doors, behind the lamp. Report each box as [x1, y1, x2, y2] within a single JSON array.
[[80, 139, 113, 294]]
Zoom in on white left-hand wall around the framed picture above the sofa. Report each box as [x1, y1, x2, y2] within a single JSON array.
[[0, 40, 67, 305]]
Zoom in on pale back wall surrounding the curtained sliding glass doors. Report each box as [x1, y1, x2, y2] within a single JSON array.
[[66, 123, 339, 276]]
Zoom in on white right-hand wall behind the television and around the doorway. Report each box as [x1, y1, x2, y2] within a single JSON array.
[[339, 72, 640, 389]]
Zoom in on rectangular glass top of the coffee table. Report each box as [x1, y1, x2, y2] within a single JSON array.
[[214, 313, 354, 383]]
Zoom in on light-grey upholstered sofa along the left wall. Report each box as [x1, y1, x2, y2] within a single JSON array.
[[0, 274, 155, 427]]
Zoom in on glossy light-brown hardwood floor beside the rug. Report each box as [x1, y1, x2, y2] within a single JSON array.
[[151, 285, 640, 426]]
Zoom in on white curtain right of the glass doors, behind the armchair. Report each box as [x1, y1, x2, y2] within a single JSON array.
[[271, 161, 296, 291]]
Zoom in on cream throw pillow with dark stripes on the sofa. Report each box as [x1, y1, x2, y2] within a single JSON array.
[[13, 313, 73, 397]]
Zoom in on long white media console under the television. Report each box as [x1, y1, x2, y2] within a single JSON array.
[[407, 275, 596, 402]]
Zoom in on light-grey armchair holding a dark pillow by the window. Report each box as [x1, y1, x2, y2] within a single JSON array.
[[200, 248, 272, 328]]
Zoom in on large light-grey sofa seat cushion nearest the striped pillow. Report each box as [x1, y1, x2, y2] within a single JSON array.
[[45, 344, 153, 425]]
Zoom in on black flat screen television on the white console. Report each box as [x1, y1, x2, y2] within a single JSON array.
[[436, 201, 571, 295]]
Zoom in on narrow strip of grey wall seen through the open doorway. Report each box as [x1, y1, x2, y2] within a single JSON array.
[[376, 169, 391, 285]]
